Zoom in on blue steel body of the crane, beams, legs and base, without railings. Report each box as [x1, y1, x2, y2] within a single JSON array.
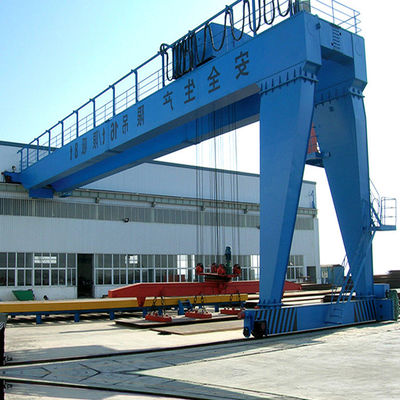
[[6, 7, 393, 336]]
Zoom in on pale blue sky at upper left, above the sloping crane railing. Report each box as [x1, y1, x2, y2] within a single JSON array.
[[0, 0, 230, 142]]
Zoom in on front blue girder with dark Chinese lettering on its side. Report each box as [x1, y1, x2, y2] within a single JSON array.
[[19, 13, 321, 189]]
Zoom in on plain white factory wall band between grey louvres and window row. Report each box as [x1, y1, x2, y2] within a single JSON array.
[[0, 216, 259, 254]]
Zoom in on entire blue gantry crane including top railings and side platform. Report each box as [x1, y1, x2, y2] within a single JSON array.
[[4, 0, 396, 337]]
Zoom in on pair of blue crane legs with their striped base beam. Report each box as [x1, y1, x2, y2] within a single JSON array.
[[244, 78, 393, 337]]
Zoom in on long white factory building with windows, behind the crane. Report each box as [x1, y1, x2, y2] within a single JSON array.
[[0, 142, 321, 301]]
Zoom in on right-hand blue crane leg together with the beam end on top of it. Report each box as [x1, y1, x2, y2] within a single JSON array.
[[314, 31, 373, 297]]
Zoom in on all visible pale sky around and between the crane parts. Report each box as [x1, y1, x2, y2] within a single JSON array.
[[0, 0, 400, 272]]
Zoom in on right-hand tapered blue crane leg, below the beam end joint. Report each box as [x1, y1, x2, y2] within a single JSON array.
[[314, 89, 373, 297]]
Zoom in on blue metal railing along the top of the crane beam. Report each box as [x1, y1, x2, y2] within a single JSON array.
[[18, 0, 360, 171]]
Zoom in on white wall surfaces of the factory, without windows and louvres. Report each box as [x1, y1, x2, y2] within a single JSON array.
[[0, 142, 320, 300]]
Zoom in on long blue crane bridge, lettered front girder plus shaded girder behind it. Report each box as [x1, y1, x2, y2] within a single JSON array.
[[9, 17, 321, 195]]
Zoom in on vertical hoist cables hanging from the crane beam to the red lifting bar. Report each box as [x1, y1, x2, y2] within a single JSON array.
[[195, 107, 242, 280]]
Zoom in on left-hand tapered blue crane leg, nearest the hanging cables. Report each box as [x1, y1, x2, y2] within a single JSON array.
[[260, 75, 315, 307]]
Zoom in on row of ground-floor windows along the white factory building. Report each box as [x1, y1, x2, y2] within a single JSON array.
[[0, 252, 307, 287]]
